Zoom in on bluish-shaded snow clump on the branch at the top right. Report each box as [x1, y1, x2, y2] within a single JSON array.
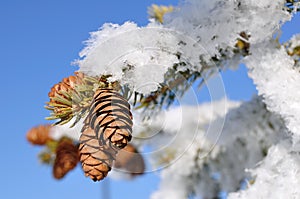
[[164, 0, 291, 57]]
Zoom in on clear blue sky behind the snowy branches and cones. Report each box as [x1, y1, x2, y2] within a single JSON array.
[[0, 0, 300, 199]]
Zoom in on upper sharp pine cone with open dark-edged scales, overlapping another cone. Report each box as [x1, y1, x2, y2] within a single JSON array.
[[85, 88, 132, 150]]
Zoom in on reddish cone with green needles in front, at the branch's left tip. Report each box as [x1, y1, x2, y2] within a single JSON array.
[[45, 72, 120, 127]]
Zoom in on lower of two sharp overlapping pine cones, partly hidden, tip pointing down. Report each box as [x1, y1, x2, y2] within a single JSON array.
[[79, 126, 117, 181]]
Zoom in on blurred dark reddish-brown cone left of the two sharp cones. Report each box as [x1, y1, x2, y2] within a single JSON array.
[[53, 138, 79, 179]]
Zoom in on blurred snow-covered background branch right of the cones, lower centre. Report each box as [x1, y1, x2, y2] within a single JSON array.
[[135, 97, 285, 199]]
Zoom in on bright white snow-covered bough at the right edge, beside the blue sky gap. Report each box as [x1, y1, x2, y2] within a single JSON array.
[[245, 42, 300, 136]]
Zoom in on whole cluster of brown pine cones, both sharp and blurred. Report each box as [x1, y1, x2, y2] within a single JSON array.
[[27, 73, 145, 181]]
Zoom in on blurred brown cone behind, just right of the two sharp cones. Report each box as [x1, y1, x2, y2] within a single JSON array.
[[114, 144, 145, 176]]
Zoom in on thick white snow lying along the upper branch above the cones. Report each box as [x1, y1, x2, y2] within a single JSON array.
[[76, 0, 291, 97]]
